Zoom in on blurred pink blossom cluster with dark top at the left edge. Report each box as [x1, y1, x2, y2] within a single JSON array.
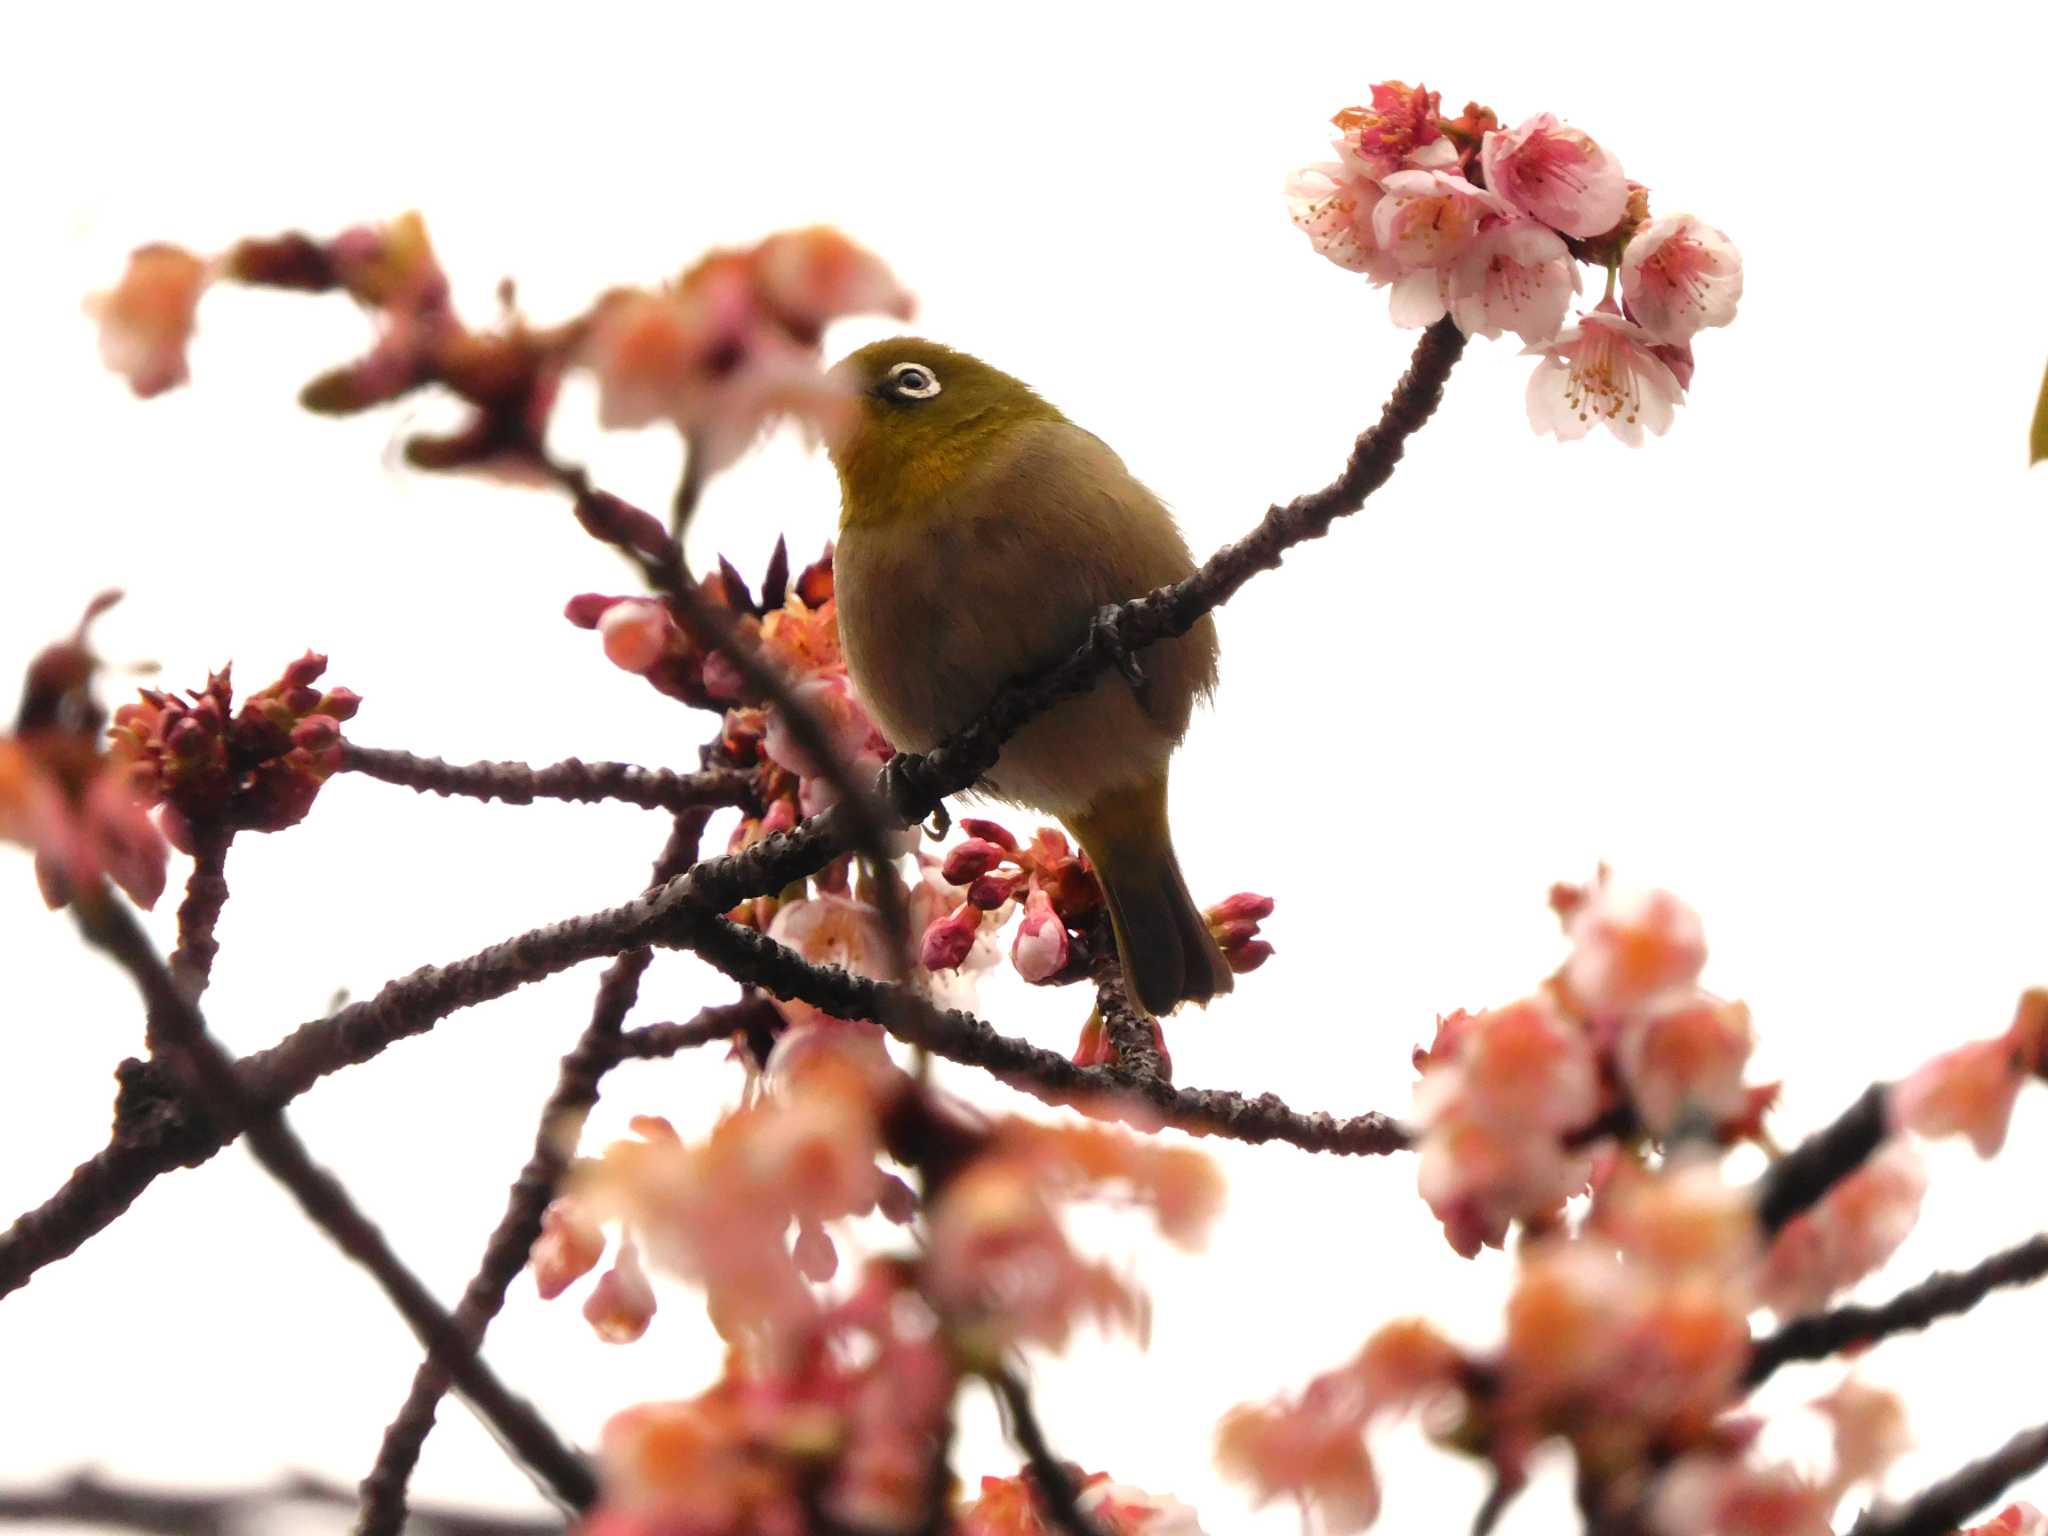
[[0, 592, 168, 907]]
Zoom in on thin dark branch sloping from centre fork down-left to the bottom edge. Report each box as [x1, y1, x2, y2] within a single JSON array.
[[356, 809, 711, 1536]]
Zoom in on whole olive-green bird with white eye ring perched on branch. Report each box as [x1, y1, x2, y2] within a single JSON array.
[[831, 338, 1231, 1014]]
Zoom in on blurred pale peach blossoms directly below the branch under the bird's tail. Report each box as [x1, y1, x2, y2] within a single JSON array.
[[532, 1020, 1221, 1362]]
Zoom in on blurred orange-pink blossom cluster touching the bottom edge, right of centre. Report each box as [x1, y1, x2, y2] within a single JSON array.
[[1219, 1161, 1905, 1536]]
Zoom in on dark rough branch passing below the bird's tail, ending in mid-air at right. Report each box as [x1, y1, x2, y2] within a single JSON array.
[[670, 909, 1409, 1155]]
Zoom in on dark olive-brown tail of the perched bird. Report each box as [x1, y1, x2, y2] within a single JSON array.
[[1069, 772, 1235, 1014]]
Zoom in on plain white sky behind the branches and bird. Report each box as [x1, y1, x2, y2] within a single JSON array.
[[0, 4, 2048, 1536]]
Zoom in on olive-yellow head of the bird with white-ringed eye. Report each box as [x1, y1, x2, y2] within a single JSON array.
[[831, 336, 1063, 526]]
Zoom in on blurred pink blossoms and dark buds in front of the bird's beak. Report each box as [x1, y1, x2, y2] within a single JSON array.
[[88, 213, 911, 479]]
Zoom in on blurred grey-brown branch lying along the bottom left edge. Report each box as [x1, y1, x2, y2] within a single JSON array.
[[0, 1473, 561, 1536]]
